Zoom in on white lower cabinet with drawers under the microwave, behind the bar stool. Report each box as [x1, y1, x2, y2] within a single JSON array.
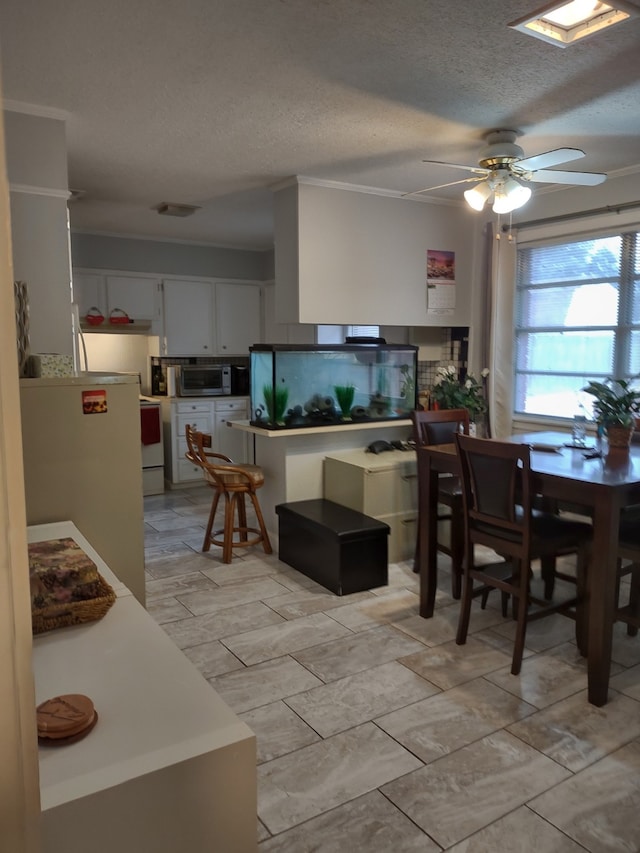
[[162, 397, 249, 486]]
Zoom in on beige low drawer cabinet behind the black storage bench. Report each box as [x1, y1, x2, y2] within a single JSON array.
[[324, 450, 418, 563]]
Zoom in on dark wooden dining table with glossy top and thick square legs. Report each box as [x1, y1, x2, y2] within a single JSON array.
[[417, 431, 640, 706]]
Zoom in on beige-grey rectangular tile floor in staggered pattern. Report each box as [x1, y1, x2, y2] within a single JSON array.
[[145, 487, 640, 853]]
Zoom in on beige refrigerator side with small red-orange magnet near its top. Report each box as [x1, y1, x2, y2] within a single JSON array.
[[20, 373, 145, 605]]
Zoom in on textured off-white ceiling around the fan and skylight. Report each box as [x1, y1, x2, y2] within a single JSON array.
[[0, 0, 640, 249]]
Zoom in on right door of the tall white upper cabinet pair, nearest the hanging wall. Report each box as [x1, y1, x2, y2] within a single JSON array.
[[216, 281, 262, 355]]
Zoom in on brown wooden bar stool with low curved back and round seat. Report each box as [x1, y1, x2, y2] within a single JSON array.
[[185, 424, 272, 563]]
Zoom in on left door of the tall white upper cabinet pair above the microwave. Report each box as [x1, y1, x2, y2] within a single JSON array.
[[162, 279, 215, 355]]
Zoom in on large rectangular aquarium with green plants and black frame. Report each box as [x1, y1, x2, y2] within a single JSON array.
[[250, 343, 418, 429]]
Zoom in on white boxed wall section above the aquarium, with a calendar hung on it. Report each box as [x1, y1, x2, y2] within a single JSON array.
[[274, 179, 476, 326]]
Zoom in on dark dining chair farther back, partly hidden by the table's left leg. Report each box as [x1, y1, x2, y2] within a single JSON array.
[[411, 409, 469, 599]]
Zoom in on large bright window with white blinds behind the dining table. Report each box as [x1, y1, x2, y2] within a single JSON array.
[[514, 232, 640, 417]]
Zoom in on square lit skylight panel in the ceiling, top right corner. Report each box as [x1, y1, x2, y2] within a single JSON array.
[[509, 0, 640, 47]]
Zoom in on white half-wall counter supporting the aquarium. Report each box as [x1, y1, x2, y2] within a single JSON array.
[[228, 418, 412, 541]]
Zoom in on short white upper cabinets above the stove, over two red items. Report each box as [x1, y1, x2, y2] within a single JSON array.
[[73, 270, 162, 335]]
